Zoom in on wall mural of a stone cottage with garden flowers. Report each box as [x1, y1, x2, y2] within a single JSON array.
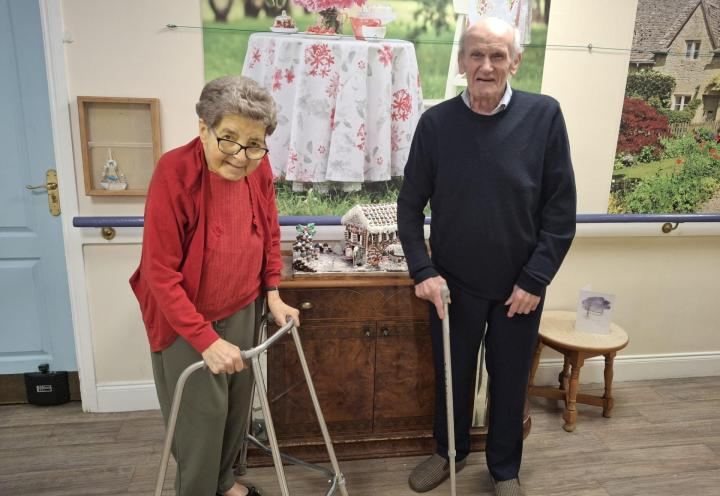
[[608, 0, 720, 214]]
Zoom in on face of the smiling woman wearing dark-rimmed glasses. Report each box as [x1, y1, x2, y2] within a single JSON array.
[[200, 114, 267, 181]]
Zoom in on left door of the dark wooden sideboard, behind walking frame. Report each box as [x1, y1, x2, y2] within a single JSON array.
[[267, 320, 376, 439]]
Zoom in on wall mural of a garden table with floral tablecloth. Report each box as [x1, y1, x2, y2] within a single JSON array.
[[200, 0, 550, 216]]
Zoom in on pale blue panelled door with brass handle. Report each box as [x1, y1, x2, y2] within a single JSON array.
[[0, 0, 77, 374]]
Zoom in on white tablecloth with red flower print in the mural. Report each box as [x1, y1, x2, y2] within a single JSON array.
[[242, 33, 422, 190]]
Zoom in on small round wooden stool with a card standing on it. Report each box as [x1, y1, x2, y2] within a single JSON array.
[[528, 311, 628, 432]]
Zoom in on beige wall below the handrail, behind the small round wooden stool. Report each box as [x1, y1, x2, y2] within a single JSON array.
[[546, 236, 720, 355]]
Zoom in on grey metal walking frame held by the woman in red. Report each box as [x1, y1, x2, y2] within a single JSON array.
[[154, 316, 352, 496]]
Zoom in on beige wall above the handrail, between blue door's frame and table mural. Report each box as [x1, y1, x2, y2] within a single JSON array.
[[63, 0, 204, 215]]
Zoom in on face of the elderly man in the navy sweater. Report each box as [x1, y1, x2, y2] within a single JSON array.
[[458, 24, 521, 102]]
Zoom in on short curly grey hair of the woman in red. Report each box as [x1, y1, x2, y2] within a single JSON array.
[[195, 76, 277, 136]]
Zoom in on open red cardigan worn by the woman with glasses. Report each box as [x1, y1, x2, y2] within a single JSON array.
[[130, 138, 282, 353]]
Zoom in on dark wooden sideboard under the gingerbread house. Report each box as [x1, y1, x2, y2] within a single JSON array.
[[248, 274, 486, 466]]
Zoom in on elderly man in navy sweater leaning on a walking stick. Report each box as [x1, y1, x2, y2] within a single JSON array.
[[398, 18, 576, 496]]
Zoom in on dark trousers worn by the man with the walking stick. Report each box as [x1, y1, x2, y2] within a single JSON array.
[[430, 283, 545, 481]]
